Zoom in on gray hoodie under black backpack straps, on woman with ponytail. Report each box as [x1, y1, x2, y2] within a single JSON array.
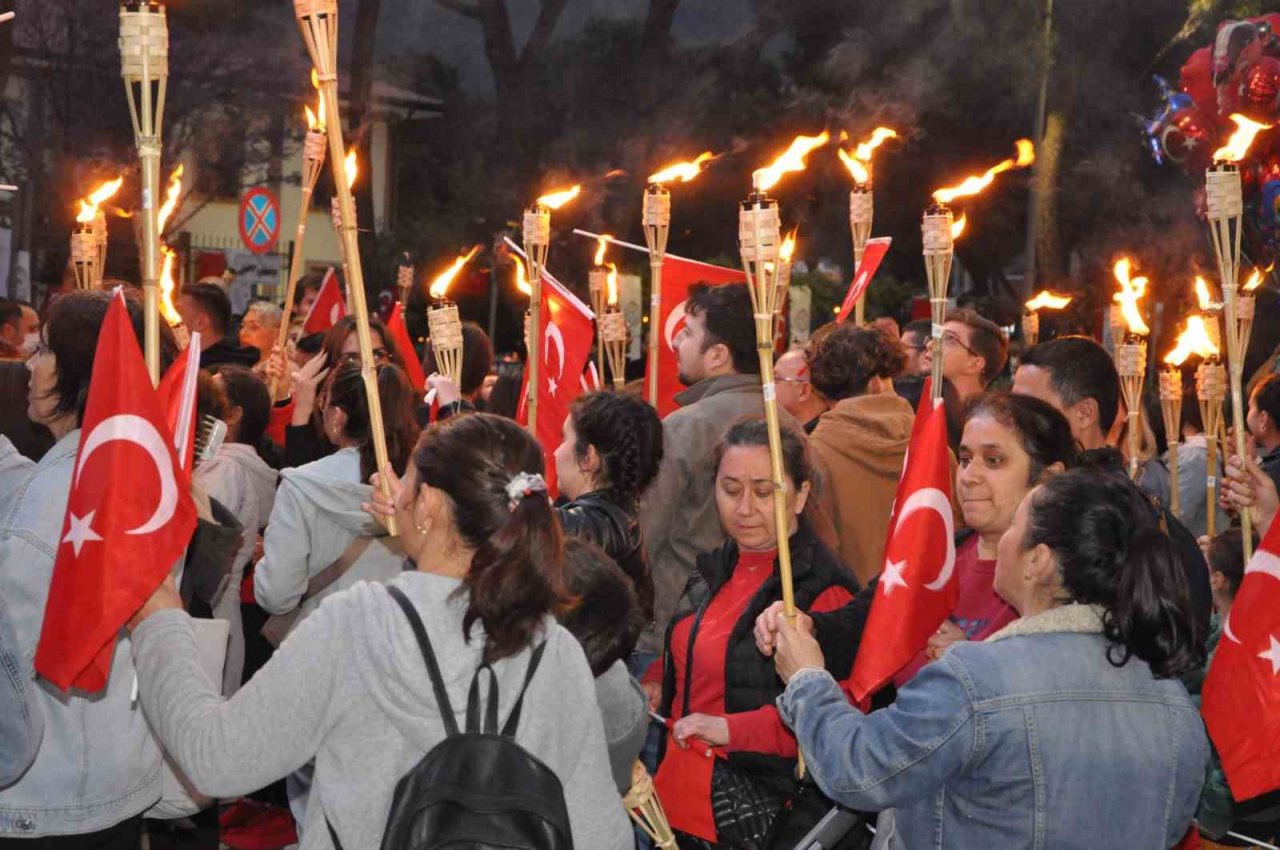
[[133, 571, 632, 850]]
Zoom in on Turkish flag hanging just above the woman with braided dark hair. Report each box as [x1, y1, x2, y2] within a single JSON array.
[[517, 271, 595, 498]]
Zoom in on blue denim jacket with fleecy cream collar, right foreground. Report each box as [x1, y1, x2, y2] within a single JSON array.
[[778, 605, 1208, 850]]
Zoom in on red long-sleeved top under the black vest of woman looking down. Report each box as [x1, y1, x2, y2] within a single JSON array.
[[644, 549, 852, 758]]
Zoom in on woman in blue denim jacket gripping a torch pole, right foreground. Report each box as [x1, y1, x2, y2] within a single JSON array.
[[762, 470, 1208, 850]]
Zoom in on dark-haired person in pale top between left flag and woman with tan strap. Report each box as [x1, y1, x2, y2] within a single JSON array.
[[193, 366, 279, 696]]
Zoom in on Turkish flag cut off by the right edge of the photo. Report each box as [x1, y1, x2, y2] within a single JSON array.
[[1201, 522, 1280, 800]]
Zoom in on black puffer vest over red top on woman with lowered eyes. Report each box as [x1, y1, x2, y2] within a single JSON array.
[[660, 520, 858, 794]]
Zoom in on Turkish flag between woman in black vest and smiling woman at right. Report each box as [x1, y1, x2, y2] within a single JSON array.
[[850, 381, 960, 710]]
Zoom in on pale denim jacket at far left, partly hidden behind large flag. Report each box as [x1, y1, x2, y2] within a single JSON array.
[[0, 430, 160, 837]]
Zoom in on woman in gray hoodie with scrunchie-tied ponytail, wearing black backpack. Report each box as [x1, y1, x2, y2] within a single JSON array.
[[131, 413, 632, 850]]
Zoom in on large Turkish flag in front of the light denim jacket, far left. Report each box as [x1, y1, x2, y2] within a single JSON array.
[[36, 294, 196, 693]]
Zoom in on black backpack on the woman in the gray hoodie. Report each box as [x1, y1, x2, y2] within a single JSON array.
[[366, 588, 573, 850]]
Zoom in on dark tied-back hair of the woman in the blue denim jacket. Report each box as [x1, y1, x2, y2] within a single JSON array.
[[1023, 470, 1204, 678]]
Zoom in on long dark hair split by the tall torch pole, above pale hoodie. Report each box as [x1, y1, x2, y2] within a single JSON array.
[[329, 364, 417, 481]]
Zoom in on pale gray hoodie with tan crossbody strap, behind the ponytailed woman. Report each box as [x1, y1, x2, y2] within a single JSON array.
[[253, 448, 404, 616]]
